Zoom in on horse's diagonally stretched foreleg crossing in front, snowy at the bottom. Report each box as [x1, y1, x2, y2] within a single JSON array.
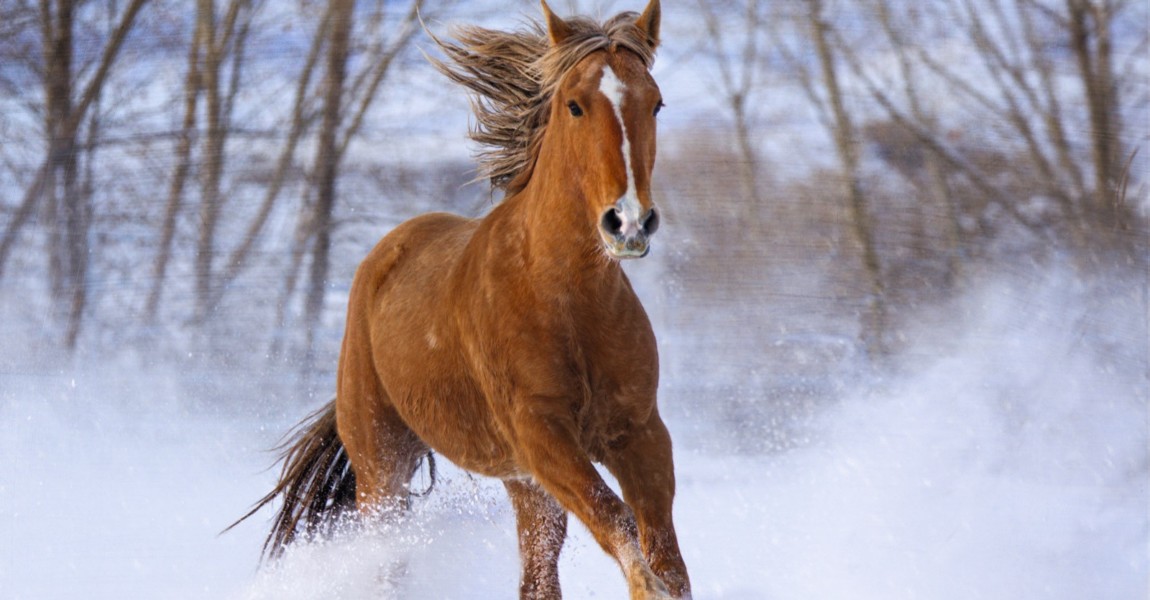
[[515, 398, 670, 600]]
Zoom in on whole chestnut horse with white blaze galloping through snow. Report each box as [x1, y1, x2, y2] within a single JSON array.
[[233, 0, 690, 598]]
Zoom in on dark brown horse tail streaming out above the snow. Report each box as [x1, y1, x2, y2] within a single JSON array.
[[224, 399, 355, 559]]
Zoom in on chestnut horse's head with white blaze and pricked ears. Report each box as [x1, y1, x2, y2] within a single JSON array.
[[543, 0, 662, 259]]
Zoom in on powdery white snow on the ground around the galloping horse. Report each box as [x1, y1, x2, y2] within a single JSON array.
[[0, 268, 1150, 600]]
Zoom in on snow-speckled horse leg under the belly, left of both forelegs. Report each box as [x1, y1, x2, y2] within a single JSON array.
[[504, 479, 567, 600]]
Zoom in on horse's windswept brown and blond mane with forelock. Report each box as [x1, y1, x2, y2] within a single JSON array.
[[430, 11, 657, 195]]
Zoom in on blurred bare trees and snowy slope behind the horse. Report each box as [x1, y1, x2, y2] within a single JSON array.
[[0, 0, 1150, 451]]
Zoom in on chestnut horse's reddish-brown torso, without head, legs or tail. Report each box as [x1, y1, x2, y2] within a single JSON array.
[[337, 192, 658, 473]]
